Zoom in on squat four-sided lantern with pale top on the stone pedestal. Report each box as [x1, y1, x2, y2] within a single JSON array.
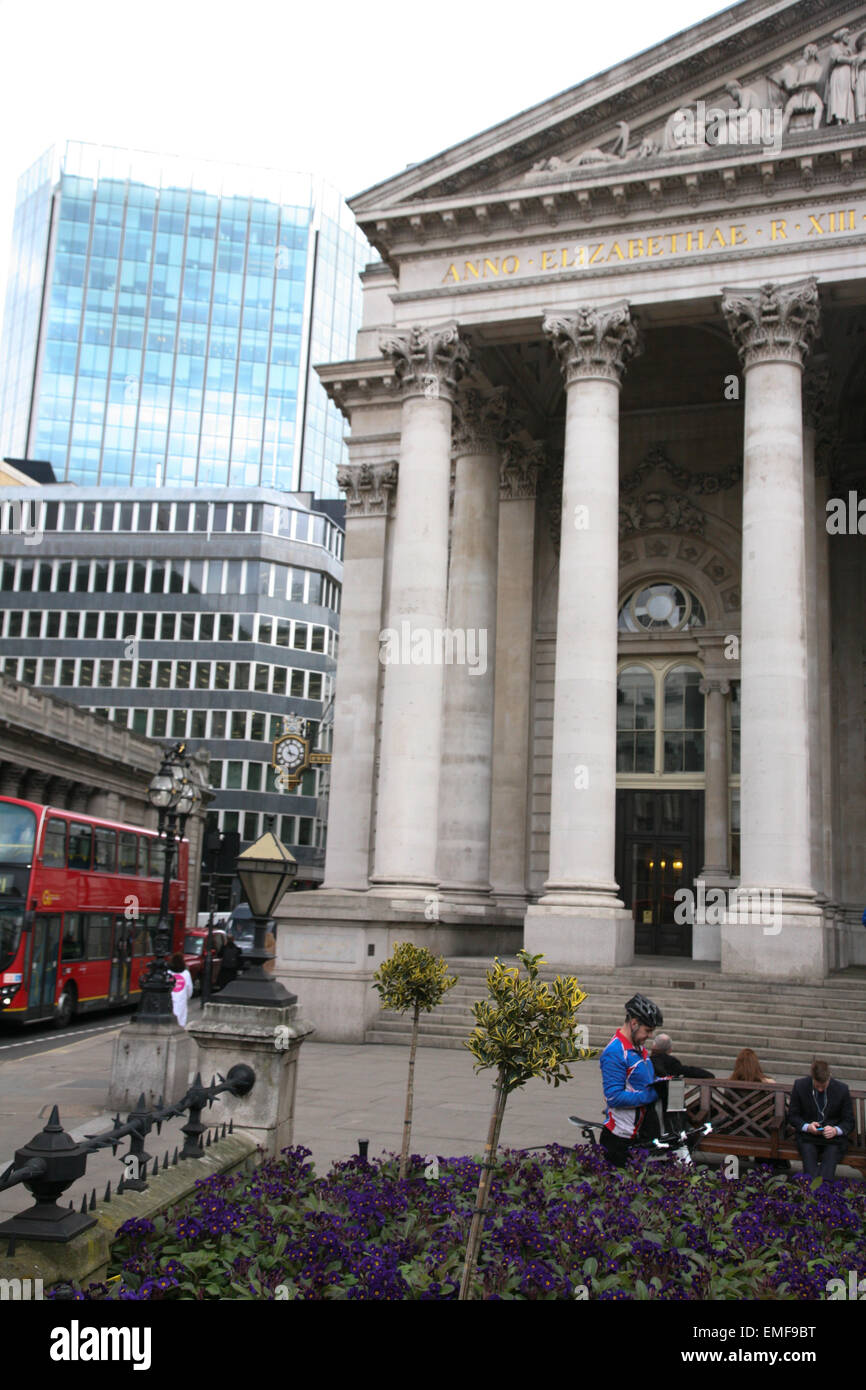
[[220, 830, 297, 1008]]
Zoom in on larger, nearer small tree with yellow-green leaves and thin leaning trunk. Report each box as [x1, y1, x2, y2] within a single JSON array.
[[460, 951, 598, 1298]]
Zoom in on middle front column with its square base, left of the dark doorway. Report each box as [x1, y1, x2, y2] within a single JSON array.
[[525, 302, 638, 969]]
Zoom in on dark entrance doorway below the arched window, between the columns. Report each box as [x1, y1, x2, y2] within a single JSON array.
[[616, 791, 703, 956]]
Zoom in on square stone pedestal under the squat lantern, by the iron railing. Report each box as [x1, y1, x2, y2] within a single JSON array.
[[188, 999, 314, 1158]]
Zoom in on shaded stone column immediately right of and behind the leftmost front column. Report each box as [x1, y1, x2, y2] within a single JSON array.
[[439, 389, 507, 899]]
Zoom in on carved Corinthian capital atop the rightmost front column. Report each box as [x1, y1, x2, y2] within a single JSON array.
[[721, 275, 820, 367]]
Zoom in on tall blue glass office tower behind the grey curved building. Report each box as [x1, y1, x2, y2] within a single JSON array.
[[0, 143, 373, 498]]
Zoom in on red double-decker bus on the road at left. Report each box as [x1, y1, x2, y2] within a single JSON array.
[[0, 796, 189, 1027]]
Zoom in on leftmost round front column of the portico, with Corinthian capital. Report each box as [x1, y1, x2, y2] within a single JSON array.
[[371, 324, 468, 897]]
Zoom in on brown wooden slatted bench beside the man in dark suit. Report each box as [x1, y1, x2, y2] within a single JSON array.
[[685, 1077, 866, 1177]]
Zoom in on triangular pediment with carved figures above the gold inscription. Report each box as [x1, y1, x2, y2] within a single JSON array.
[[350, 0, 866, 259]]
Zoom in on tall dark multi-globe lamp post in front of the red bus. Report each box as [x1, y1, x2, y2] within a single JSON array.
[[135, 744, 199, 1024]]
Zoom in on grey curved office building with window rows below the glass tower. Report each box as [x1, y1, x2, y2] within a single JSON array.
[[0, 487, 343, 883]]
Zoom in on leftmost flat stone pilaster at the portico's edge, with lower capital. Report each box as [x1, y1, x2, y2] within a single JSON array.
[[324, 460, 398, 891]]
